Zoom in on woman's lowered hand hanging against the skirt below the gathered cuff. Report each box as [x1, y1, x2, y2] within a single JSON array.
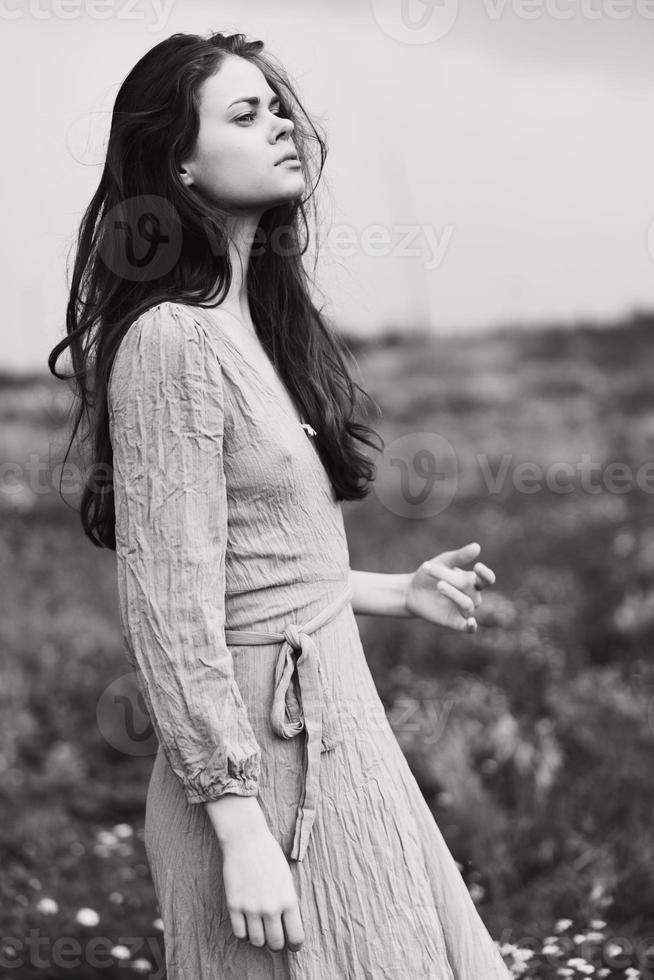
[[220, 825, 304, 952]]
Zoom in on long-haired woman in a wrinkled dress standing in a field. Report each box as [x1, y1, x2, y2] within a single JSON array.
[[50, 34, 510, 980]]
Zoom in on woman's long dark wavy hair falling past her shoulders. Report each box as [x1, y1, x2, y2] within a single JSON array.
[[48, 33, 383, 551]]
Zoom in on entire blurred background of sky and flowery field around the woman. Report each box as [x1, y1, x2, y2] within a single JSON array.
[[0, 0, 654, 980]]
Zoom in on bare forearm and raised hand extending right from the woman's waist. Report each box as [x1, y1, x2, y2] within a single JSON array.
[[350, 541, 495, 633]]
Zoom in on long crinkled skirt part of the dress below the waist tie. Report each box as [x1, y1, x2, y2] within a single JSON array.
[[145, 603, 511, 980]]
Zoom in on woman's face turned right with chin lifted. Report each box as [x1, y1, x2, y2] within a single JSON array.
[[181, 55, 304, 213]]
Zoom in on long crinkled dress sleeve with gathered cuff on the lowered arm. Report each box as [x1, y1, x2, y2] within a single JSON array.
[[109, 303, 261, 803]]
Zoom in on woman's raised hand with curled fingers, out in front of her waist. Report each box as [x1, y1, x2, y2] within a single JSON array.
[[405, 541, 495, 633]]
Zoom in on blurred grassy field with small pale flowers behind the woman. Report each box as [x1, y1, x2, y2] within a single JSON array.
[[0, 317, 654, 980]]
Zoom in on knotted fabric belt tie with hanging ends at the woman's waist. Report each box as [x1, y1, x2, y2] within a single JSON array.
[[225, 584, 353, 861]]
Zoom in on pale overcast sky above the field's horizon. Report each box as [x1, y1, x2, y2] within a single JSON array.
[[0, 0, 654, 369]]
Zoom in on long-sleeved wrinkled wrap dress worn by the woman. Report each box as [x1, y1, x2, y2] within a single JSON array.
[[109, 302, 511, 980]]
